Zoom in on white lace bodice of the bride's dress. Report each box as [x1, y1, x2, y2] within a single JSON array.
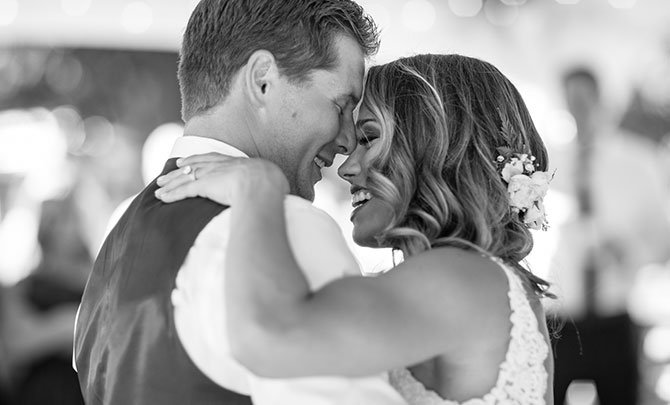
[[389, 258, 549, 405]]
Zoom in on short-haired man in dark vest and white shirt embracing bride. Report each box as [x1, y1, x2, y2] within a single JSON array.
[[74, 0, 402, 405]]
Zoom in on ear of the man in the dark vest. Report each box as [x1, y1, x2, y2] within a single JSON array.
[[244, 49, 279, 106]]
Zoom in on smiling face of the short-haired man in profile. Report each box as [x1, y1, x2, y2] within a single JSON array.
[[262, 35, 365, 201]]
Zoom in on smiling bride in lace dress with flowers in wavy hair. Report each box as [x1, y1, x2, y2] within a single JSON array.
[[159, 55, 552, 405]]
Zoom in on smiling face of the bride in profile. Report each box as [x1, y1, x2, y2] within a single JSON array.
[[338, 105, 393, 247]]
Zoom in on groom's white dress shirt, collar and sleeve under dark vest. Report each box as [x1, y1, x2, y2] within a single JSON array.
[[171, 136, 405, 405]]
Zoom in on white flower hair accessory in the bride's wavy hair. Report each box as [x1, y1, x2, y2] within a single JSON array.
[[495, 147, 554, 231]]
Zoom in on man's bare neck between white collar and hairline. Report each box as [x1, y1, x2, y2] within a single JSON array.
[[184, 103, 259, 157]]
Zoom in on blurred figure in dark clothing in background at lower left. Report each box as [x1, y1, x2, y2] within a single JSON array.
[[2, 193, 92, 405]]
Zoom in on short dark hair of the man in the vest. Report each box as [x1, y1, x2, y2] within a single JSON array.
[[178, 0, 379, 121]]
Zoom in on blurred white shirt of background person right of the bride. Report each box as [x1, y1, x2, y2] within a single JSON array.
[[547, 127, 670, 318]]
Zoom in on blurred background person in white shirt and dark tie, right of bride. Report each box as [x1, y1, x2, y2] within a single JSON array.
[[551, 66, 670, 405]]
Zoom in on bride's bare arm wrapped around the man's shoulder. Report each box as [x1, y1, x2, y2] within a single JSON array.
[[155, 155, 508, 377]]
